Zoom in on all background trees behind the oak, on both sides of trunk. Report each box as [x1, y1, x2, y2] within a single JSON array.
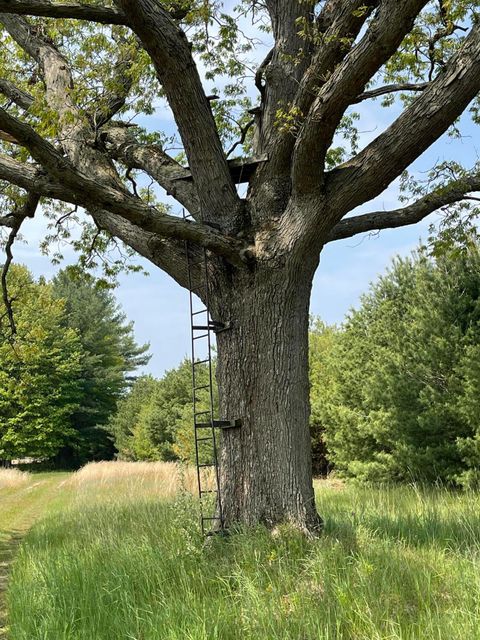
[[0, 244, 480, 487]]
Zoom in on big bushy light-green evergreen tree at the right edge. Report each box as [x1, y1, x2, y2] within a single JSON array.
[[317, 248, 480, 484]]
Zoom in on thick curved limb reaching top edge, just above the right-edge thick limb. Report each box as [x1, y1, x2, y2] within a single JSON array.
[[293, 0, 429, 193]]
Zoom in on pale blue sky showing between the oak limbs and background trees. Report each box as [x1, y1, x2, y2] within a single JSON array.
[[11, 10, 480, 376]]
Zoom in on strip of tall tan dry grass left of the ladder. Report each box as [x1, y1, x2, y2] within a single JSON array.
[[69, 461, 208, 498]]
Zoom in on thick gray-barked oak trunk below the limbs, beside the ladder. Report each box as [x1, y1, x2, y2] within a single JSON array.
[[215, 264, 321, 533]]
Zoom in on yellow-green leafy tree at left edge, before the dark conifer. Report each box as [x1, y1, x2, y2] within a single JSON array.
[[0, 266, 84, 460]]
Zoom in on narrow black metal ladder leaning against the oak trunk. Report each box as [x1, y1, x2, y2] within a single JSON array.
[[183, 211, 240, 535]]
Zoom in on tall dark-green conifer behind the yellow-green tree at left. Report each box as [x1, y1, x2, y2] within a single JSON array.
[[53, 269, 150, 465]]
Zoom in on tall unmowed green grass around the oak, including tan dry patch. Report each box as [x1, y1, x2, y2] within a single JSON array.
[[0, 465, 480, 640]]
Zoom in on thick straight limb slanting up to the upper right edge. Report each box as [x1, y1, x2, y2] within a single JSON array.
[[327, 23, 480, 219]]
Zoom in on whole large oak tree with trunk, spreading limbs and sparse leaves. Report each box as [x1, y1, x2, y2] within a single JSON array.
[[0, 0, 480, 530]]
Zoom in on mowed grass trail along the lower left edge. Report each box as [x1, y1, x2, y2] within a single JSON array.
[[0, 473, 70, 640]]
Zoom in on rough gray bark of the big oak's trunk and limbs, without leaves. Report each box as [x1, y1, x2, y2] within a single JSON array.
[[0, 0, 480, 531]]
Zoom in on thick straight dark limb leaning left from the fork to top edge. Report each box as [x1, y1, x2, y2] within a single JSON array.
[[115, 0, 243, 233]]
